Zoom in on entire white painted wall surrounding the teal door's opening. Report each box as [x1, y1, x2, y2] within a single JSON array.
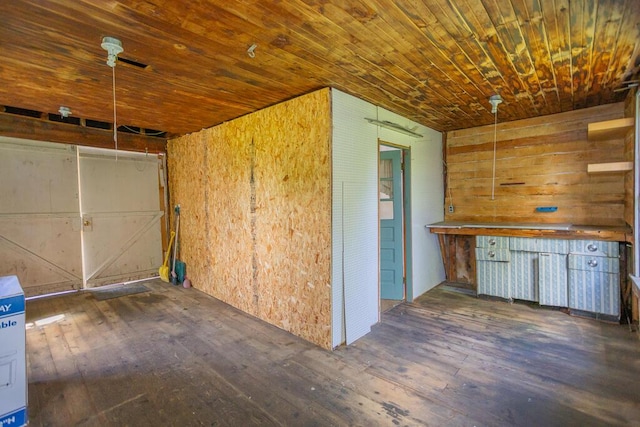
[[332, 89, 445, 347]]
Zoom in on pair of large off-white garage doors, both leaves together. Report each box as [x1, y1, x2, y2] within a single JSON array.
[[0, 137, 163, 296]]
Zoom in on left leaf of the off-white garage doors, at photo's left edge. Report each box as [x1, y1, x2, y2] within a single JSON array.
[[0, 138, 82, 296]]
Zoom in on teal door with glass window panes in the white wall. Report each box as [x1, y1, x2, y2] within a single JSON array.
[[379, 150, 404, 300]]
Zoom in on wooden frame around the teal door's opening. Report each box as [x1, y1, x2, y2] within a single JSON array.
[[378, 144, 413, 302]]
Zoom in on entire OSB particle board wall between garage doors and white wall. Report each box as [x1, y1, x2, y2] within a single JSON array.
[[168, 89, 331, 349]]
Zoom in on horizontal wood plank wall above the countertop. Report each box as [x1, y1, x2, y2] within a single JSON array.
[[445, 103, 625, 226]]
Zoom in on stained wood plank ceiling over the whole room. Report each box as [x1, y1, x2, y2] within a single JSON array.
[[0, 0, 640, 135]]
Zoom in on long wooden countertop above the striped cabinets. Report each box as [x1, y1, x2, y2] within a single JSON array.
[[425, 221, 633, 243]]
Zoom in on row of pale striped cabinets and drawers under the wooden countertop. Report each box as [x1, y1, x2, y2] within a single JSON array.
[[475, 236, 620, 318]]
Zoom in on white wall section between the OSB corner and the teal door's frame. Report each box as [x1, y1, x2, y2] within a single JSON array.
[[331, 89, 379, 347]]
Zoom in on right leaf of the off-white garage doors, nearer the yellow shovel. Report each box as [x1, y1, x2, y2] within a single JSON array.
[[79, 147, 163, 287]]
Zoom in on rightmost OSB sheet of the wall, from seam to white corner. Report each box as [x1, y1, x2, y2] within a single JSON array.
[[255, 90, 331, 348]]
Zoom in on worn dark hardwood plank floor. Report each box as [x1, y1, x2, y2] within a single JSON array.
[[27, 281, 640, 426]]
